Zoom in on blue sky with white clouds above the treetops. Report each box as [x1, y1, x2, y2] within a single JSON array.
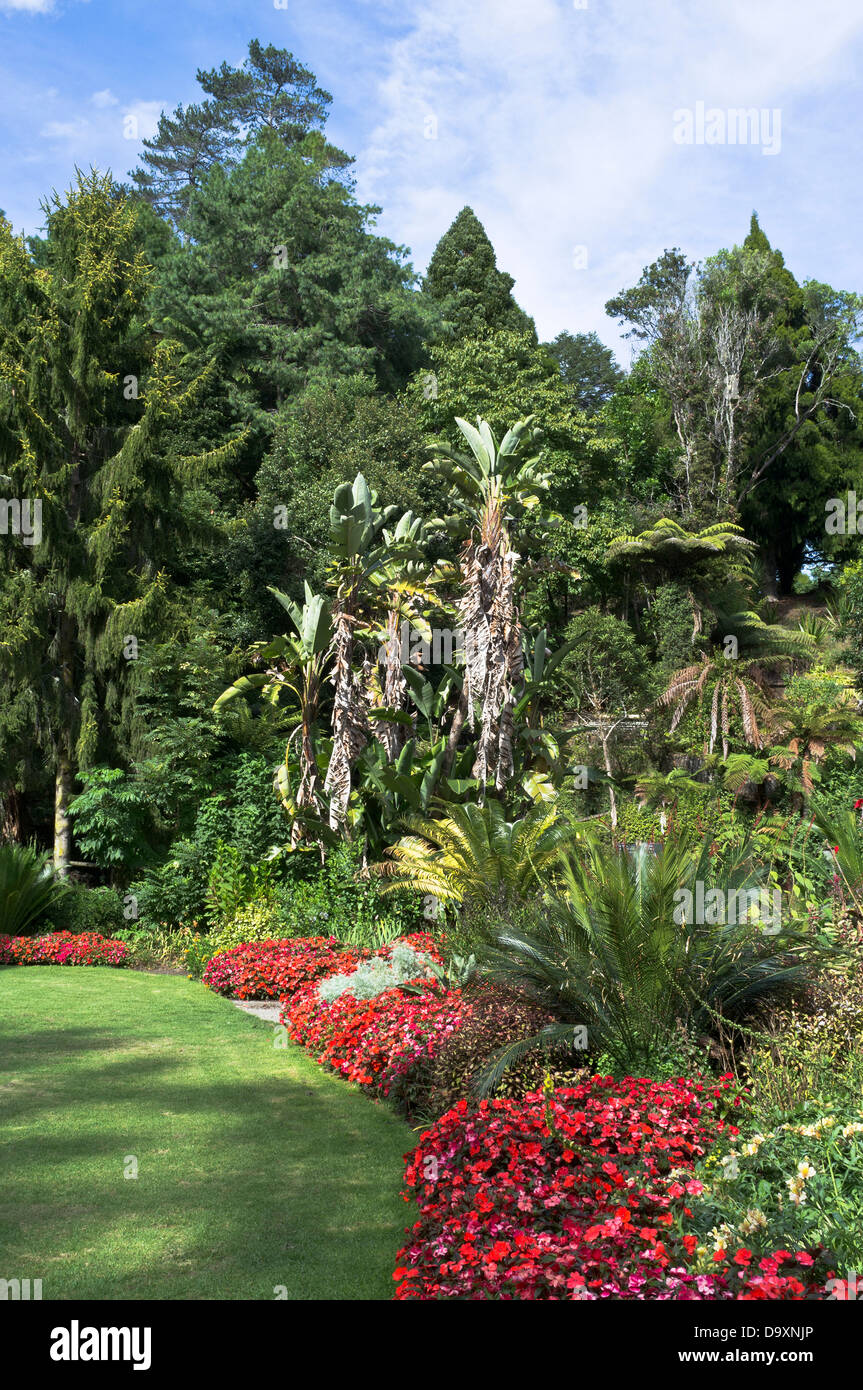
[[0, 0, 863, 361]]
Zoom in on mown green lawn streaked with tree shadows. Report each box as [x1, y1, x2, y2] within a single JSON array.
[[0, 966, 416, 1300]]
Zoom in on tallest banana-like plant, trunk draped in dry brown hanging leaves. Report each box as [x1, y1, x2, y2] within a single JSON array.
[[425, 416, 548, 799]]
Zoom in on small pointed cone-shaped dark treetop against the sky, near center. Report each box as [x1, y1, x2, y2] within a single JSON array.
[[422, 207, 536, 341]]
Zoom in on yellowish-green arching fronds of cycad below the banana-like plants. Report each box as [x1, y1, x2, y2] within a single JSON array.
[[370, 801, 586, 904]]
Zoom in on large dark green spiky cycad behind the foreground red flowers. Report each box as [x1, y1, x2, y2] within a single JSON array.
[[478, 840, 812, 1090]]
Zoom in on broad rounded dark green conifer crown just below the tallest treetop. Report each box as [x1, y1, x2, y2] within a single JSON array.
[[154, 129, 422, 442]]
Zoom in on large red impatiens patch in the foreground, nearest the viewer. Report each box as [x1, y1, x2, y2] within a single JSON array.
[[395, 1077, 820, 1300]]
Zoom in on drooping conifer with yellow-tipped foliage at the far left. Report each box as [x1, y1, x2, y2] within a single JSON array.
[[0, 172, 232, 873]]
